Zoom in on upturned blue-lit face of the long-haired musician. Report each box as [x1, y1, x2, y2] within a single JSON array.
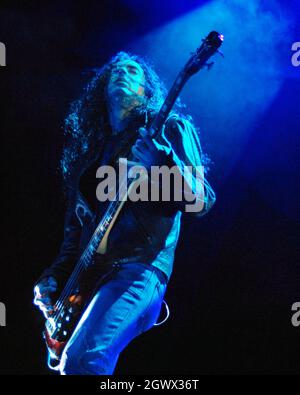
[[107, 59, 145, 104]]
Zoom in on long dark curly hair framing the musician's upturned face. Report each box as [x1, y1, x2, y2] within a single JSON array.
[[60, 51, 207, 191]]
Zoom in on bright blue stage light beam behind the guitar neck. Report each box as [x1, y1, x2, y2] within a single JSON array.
[[127, 0, 294, 183]]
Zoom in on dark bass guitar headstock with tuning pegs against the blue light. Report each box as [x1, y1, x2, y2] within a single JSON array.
[[184, 31, 224, 77]]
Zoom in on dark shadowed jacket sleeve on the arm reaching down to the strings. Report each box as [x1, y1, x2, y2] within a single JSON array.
[[36, 193, 82, 288]]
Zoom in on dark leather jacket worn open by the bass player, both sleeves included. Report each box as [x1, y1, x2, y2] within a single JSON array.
[[39, 116, 215, 285]]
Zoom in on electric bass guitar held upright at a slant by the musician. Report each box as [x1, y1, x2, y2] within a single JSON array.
[[44, 31, 223, 370]]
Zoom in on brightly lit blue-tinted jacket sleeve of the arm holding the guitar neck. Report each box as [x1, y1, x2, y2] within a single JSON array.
[[156, 115, 216, 216]]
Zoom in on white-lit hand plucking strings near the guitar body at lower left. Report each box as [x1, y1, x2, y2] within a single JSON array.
[[33, 276, 57, 318]]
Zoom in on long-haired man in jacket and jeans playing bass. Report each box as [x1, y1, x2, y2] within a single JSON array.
[[35, 52, 215, 374]]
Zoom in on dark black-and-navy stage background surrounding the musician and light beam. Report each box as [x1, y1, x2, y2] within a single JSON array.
[[0, 0, 300, 374]]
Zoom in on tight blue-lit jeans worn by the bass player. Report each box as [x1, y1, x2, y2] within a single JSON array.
[[60, 263, 167, 375]]
